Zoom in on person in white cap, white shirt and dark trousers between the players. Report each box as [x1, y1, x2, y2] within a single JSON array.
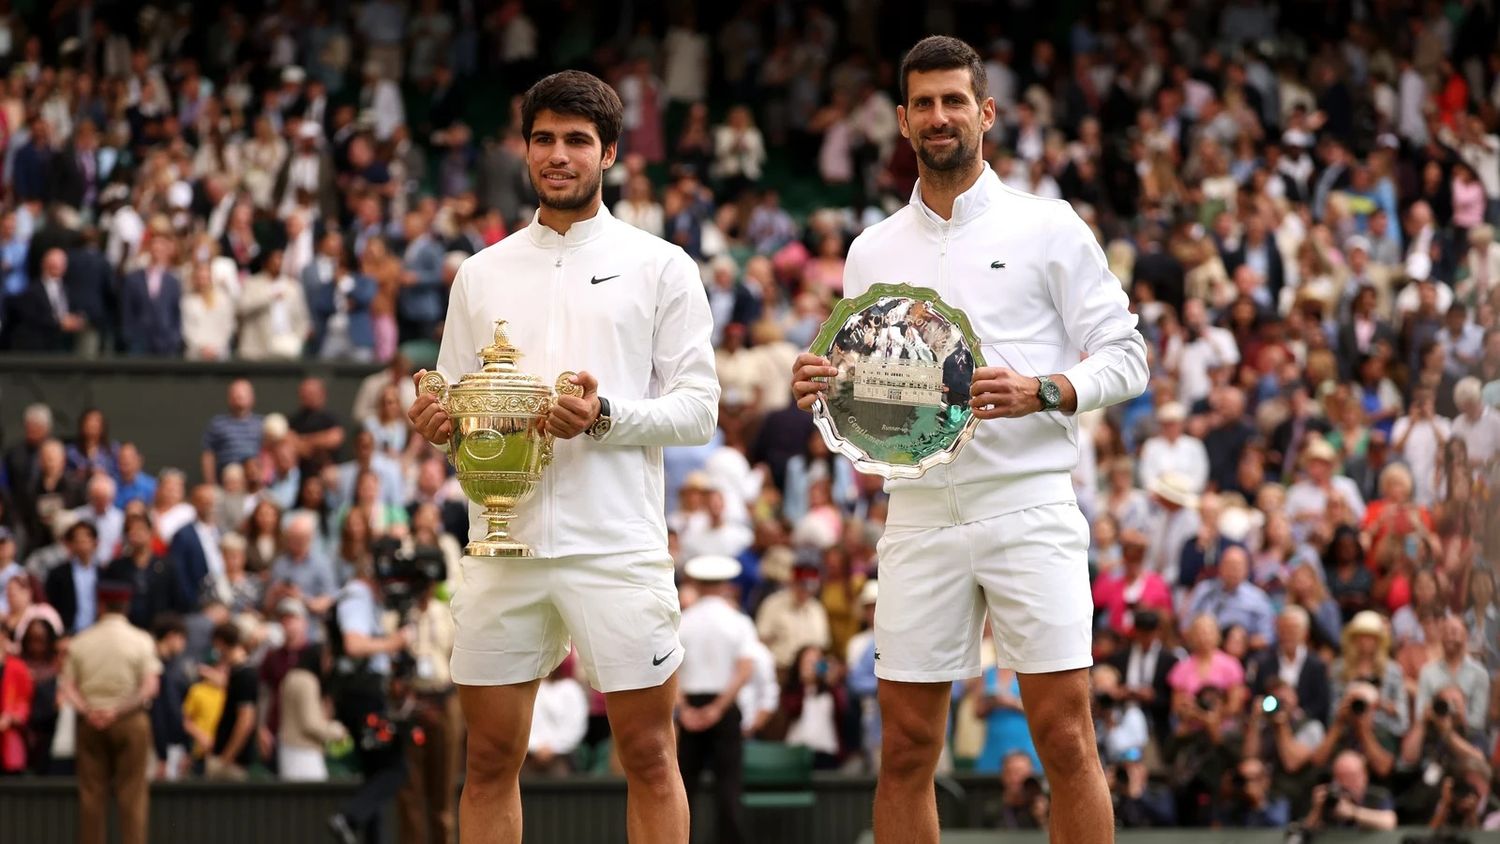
[[677, 556, 759, 844]]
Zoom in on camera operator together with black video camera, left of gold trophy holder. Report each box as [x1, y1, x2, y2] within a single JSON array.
[[329, 541, 447, 844]]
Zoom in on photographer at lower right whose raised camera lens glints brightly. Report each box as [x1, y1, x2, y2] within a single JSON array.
[[1242, 675, 1326, 823]]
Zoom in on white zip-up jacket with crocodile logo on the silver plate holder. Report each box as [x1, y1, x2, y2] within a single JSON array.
[[845, 165, 1148, 528]]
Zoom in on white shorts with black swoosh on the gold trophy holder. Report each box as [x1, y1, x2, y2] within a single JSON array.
[[452, 555, 683, 693]]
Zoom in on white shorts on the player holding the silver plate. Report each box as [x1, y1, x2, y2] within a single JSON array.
[[875, 502, 1094, 682]]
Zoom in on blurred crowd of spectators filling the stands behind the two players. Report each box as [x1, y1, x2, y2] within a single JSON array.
[[0, 0, 1500, 828]]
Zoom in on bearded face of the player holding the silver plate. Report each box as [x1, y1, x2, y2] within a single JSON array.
[[896, 67, 995, 172]]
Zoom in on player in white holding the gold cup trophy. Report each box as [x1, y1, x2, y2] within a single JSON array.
[[410, 70, 719, 844]]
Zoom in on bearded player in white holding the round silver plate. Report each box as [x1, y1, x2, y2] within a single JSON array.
[[792, 37, 1146, 844]]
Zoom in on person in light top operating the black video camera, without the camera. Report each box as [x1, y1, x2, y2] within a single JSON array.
[[329, 558, 411, 844]]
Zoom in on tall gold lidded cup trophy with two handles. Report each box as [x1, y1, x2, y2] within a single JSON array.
[[422, 319, 584, 556]]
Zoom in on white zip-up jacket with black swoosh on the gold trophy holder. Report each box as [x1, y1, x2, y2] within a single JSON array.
[[438, 205, 719, 559]]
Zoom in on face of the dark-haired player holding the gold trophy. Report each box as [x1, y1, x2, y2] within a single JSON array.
[[527, 109, 617, 211]]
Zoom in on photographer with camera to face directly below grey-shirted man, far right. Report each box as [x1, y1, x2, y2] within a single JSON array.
[[1397, 685, 1485, 823]]
